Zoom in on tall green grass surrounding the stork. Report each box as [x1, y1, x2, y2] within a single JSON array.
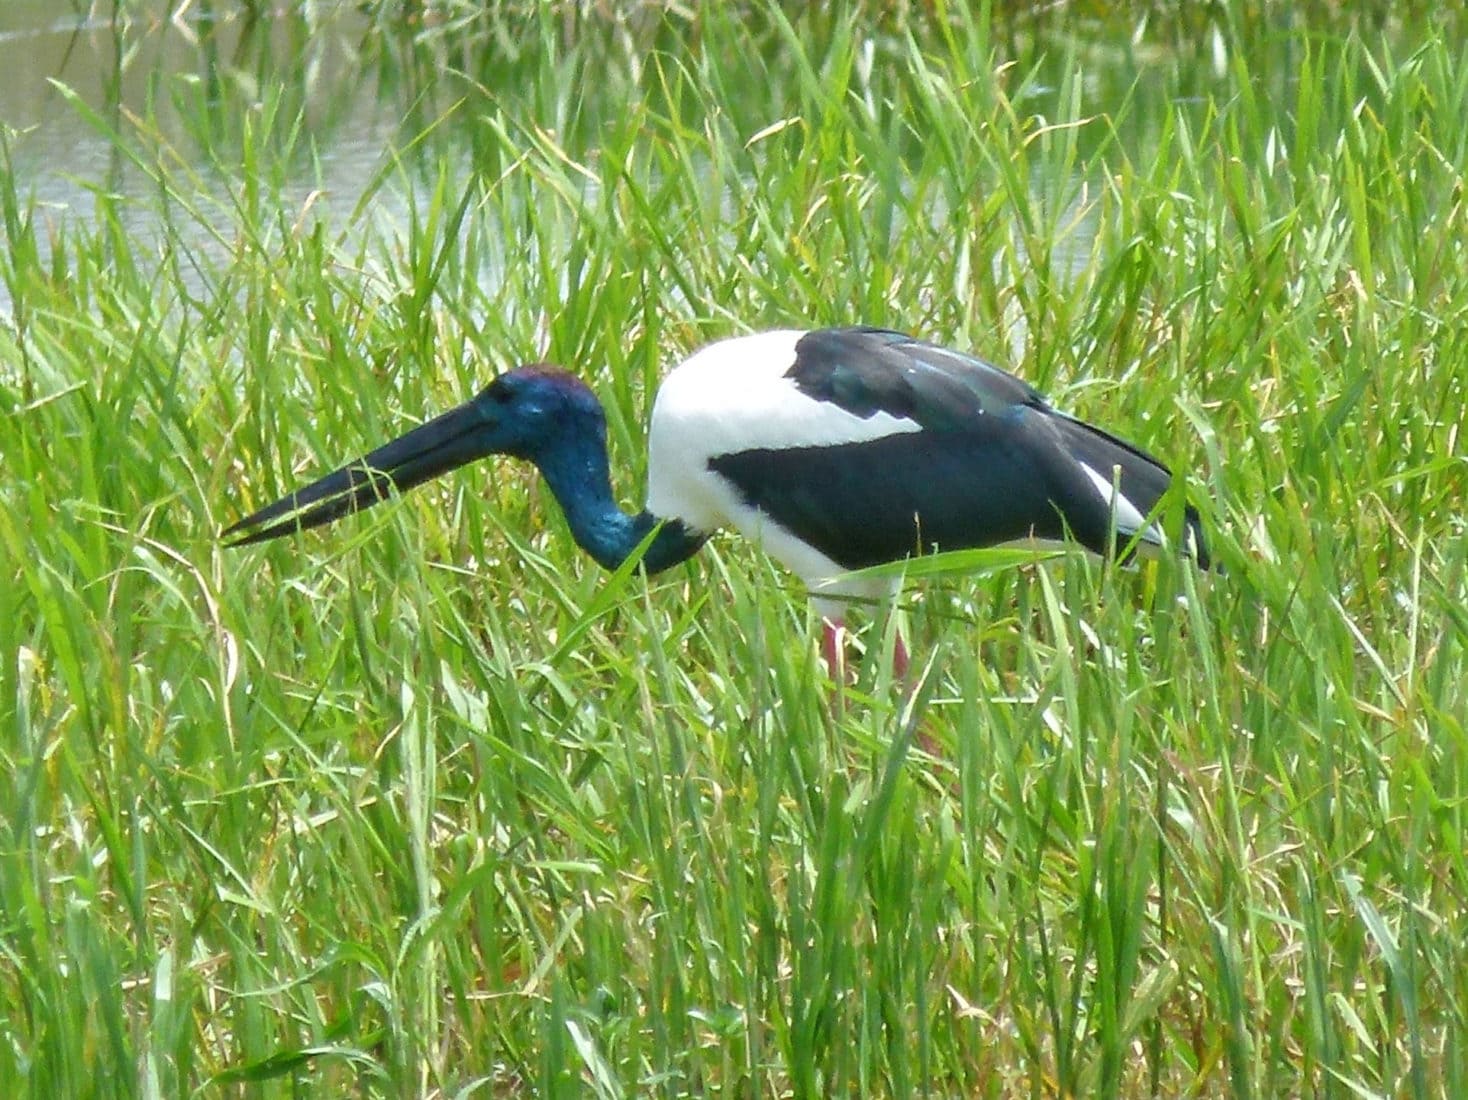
[[0, 4, 1468, 1097]]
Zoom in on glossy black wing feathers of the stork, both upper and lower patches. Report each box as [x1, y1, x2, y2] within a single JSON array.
[[709, 328, 1207, 568]]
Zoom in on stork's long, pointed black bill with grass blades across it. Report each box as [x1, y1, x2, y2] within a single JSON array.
[[220, 402, 490, 546]]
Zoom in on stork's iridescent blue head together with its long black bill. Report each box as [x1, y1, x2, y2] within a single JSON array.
[[225, 363, 606, 546]]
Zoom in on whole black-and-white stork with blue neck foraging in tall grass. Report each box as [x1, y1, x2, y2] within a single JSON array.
[[225, 328, 1207, 671]]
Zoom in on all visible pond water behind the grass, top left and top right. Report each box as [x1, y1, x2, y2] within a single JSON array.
[[0, 0, 1426, 324]]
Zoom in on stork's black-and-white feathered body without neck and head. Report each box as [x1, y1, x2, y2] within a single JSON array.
[[647, 329, 1196, 617]]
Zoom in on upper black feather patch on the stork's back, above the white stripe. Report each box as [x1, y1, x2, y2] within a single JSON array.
[[787, 328, 1048, 430]]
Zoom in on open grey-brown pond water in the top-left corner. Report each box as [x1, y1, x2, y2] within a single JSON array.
[[0, 0, 422, 313]]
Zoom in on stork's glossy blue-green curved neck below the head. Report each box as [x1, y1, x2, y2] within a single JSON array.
[[536, 433, 706, 573]]
